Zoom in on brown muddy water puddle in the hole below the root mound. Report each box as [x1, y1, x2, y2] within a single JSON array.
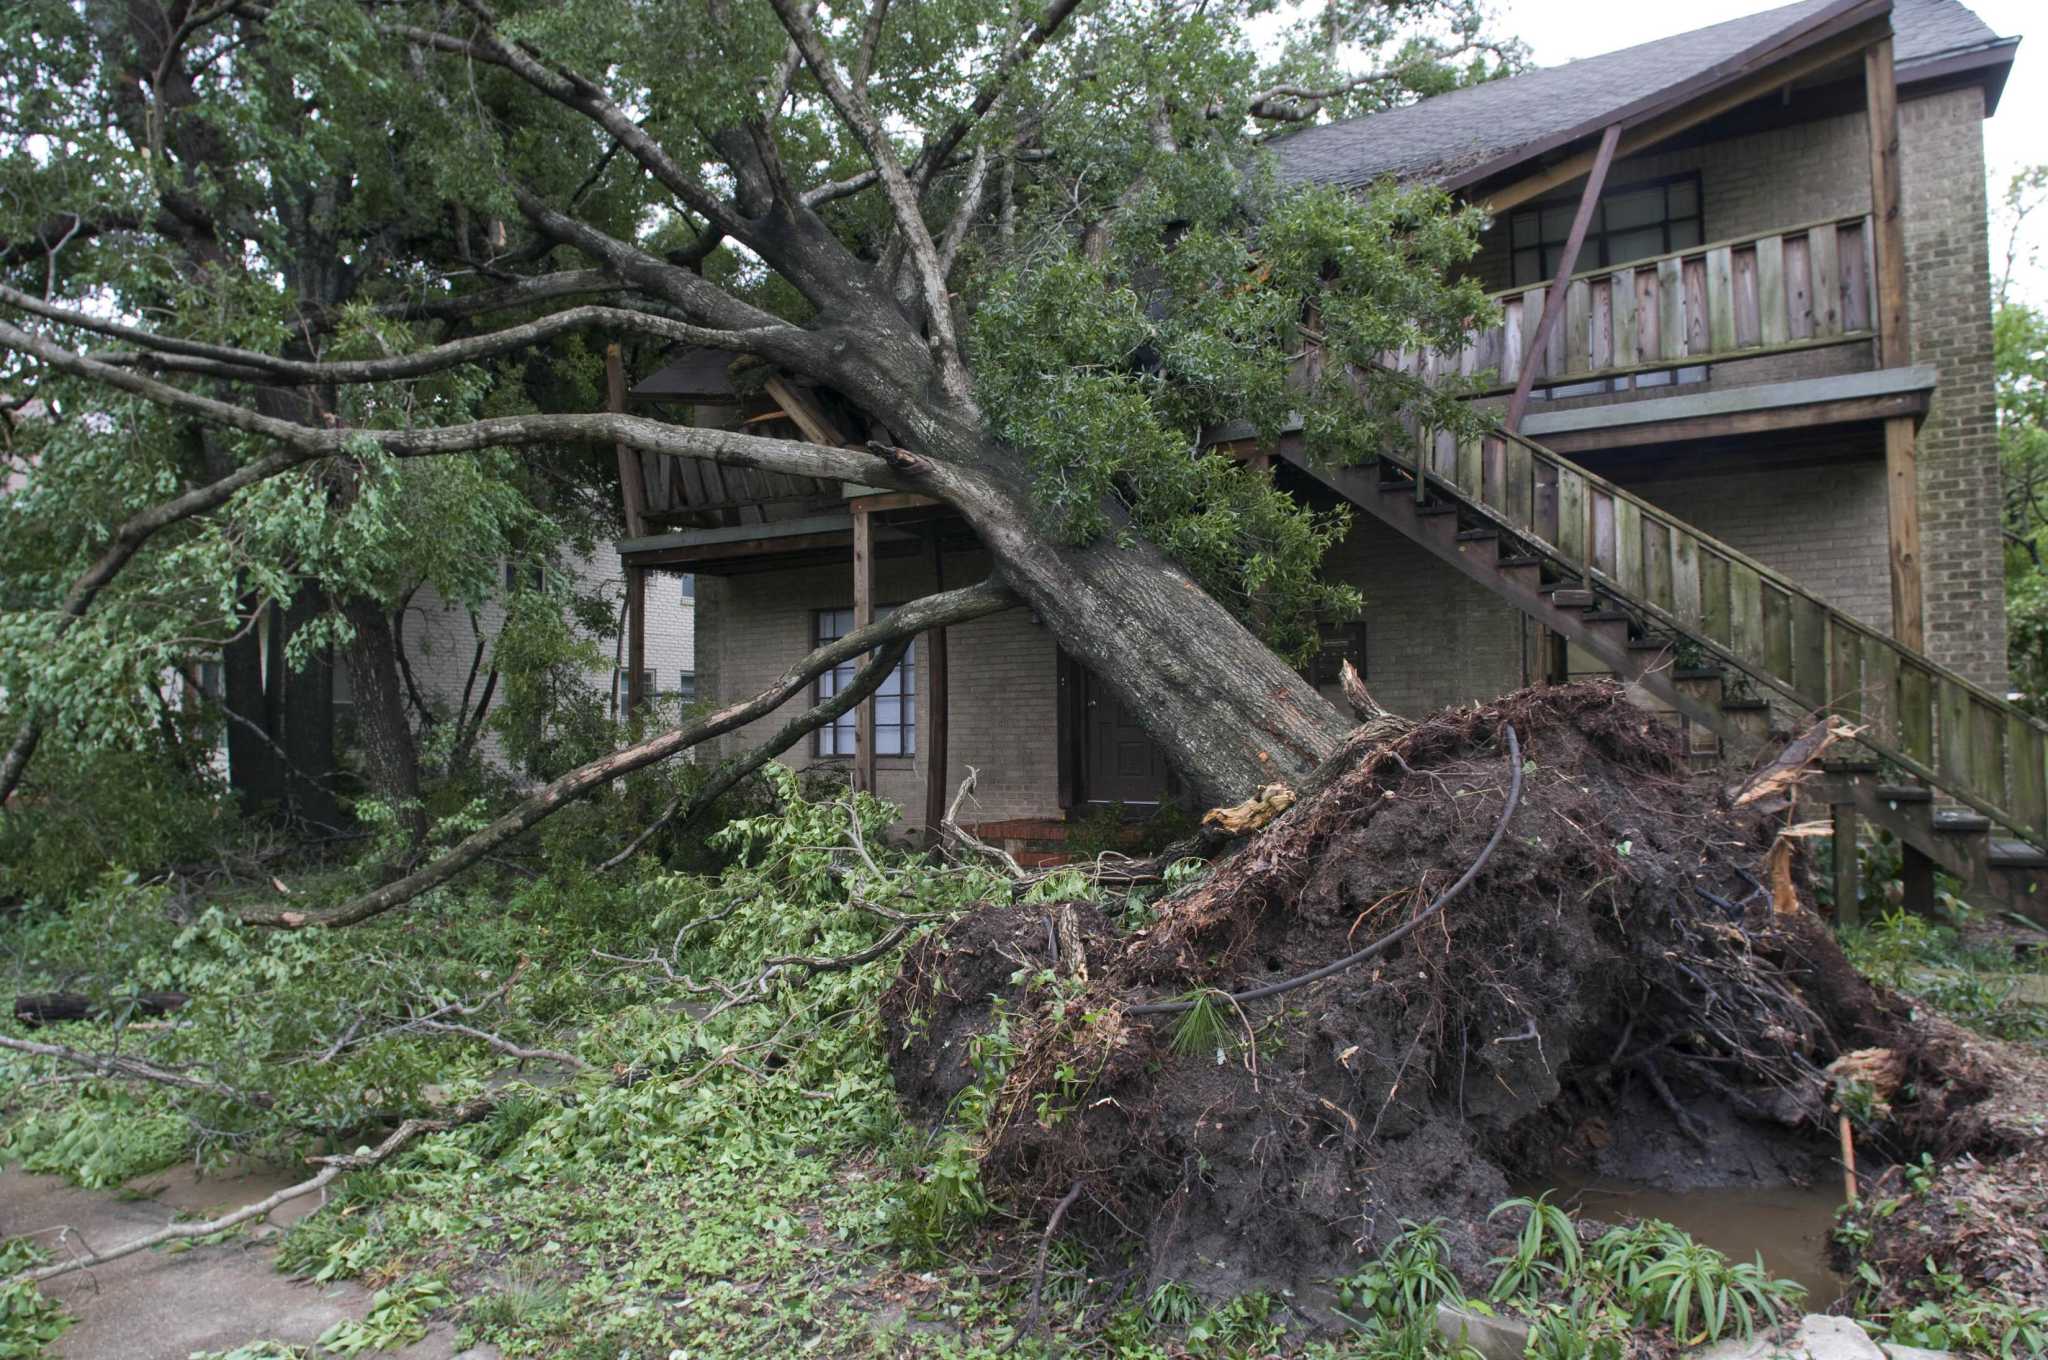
[[1526, 1180, 1847, 1313]]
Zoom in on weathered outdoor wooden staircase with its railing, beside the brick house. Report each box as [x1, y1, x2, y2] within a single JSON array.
[[1280, 434, 2048, 924]]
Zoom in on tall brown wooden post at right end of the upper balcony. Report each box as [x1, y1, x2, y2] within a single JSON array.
[[1864, 37, 1927, 651]]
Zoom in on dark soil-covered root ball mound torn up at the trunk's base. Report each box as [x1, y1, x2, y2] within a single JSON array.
[[885, 684, 1998, 1292]]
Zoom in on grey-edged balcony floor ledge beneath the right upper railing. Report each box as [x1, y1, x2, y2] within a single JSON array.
[[1522, 365, 1937, 455]]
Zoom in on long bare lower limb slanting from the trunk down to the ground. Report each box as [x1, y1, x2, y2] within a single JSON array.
[[242, 582, 1016, 930]]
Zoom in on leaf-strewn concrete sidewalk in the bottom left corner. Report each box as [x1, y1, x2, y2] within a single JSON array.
[[0, 1167, 496, 1360]]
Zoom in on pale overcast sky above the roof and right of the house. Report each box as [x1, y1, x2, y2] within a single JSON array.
[[1495, 0, 2048, 303]]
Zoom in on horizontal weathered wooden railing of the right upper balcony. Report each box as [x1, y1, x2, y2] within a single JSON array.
[[1382, 217, 1874, 391]]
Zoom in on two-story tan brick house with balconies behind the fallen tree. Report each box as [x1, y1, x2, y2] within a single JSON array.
[[602, 0, 2048, 913]]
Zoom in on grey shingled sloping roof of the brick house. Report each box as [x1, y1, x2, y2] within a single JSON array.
[[1270, 0, 2017, 186]]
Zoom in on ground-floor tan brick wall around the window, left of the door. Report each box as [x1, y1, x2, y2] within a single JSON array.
[[698, 555, 1059, 825]]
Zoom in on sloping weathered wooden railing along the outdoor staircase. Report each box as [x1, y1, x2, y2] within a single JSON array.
[[1389, 434, 2048, 848]]
